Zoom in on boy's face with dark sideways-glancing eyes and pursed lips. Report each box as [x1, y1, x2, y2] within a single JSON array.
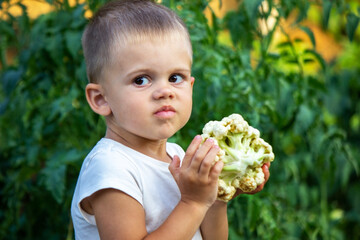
[[98, 34, 194, 140]]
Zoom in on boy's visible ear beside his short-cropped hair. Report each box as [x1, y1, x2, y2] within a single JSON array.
[[85, 83, 111, 116]]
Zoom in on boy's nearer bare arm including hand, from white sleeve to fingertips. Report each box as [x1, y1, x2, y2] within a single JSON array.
[[82, 136, 227, 240]]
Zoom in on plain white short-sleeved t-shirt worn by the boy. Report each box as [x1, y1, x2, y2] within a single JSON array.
[[71, 138, 202, 240]]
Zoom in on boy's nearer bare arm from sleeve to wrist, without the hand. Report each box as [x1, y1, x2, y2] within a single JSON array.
[[91, 189, 207, 240]]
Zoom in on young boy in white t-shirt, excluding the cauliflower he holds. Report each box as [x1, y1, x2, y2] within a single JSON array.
[[71, 0, 269, 240]]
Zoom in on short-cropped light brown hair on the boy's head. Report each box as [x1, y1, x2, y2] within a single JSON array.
[[82, 0, 192, 83]]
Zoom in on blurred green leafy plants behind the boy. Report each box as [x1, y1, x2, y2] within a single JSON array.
[[0, 0, 360, 239]]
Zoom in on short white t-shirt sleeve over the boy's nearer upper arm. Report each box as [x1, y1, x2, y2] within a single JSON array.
[[77, 149, 143, 224]]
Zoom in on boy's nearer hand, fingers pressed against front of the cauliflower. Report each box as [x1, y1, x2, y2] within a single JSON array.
[[169, 136, 223, 207]]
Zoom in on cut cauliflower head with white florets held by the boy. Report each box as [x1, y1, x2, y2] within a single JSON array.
[[201, 113, 274, 202]]
